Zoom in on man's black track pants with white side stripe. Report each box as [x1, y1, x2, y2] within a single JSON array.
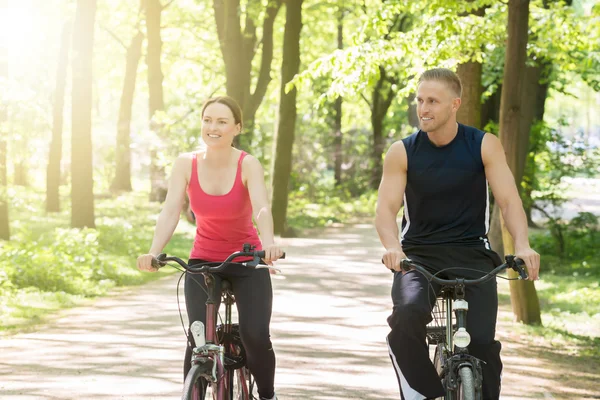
[[387, 246, 502, 400]]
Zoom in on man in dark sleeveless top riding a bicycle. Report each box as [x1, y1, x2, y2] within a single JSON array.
[[375, 68, 540, 400]]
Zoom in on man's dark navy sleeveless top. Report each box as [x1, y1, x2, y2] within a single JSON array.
[[401, 124, 490, 249]]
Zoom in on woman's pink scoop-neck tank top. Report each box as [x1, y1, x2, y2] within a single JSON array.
[[187, 151, 262, 261]]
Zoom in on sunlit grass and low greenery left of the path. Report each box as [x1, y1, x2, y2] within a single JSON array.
[[0, 188, 193, 334]]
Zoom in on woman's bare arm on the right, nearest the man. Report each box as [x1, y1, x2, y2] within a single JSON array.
[[242, 155, 283, 264]]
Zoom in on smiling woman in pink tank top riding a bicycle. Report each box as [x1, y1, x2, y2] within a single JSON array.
[[137, 97, 283, 399]]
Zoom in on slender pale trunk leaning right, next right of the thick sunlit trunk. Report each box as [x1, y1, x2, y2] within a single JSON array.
[[110, 31, 144, 192]]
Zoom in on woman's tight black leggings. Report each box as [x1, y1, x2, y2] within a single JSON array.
[[183, 259, 275, 399]]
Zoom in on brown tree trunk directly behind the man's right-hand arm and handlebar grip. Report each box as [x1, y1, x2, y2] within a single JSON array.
[[500, 0, 542, 325]]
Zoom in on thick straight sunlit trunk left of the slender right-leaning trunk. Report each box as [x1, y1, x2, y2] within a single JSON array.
[[71, 0, 96, 228]]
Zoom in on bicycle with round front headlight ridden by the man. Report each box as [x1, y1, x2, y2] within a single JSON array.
[[400, 255, 527, 400]]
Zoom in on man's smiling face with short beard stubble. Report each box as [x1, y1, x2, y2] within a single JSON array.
[[416, 80, 460, 132]]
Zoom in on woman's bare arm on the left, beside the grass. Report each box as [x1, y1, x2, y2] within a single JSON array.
[[137, 155, 191, 272]]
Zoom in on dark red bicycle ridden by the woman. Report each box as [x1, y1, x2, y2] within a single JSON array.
[[152, 244, 285, 400]]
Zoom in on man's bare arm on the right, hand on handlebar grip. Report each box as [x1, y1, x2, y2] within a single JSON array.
[[481, 133, 540, 280]]
